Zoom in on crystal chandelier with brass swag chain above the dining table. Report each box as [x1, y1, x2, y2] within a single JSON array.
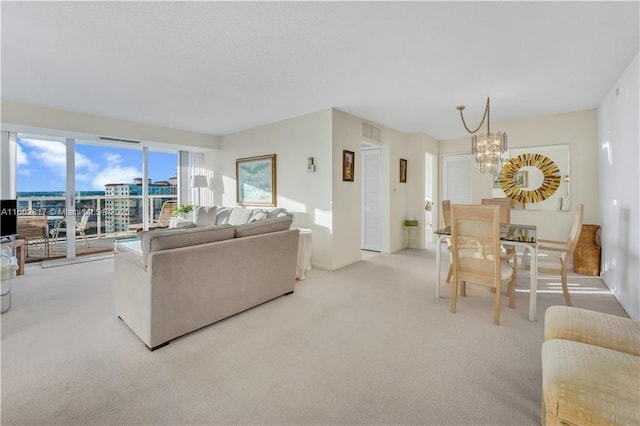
[[456, 98, 507, 173]]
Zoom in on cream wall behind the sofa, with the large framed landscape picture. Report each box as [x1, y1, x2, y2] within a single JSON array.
[[204, 109, 334, 269]]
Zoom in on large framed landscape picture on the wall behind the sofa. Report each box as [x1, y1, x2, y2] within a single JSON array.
[[236, 154, 277, 206]]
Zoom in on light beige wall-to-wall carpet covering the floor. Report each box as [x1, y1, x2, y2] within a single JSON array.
[[1, 246, 625, 425]]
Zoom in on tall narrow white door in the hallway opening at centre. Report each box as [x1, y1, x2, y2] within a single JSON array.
[[362, 148, 380, 251]]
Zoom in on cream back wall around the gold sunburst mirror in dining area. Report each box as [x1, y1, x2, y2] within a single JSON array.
[[440, 110, 600, 240]]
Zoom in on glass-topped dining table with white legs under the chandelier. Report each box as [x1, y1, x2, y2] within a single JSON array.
[[434, 224, 538, 321]]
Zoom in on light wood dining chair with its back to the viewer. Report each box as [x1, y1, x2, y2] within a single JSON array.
[[451, 205, 515, 325]]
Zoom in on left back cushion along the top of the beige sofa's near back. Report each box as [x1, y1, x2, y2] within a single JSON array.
[[142, 225, 234, 267]]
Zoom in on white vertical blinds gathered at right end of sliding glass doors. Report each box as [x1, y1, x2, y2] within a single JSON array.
[[178, 151, 214, 206]]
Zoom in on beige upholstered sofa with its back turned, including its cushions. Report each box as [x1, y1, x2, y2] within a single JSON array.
[[114, 207, 299, 350]]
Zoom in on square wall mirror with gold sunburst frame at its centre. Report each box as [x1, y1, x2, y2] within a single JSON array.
[[492, 145, 571, 211]]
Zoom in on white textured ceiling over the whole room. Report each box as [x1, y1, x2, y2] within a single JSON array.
[[1, 1, 640, 140]]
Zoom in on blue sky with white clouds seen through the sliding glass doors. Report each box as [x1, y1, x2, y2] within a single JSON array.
[[17, 138, 177, 192]]
